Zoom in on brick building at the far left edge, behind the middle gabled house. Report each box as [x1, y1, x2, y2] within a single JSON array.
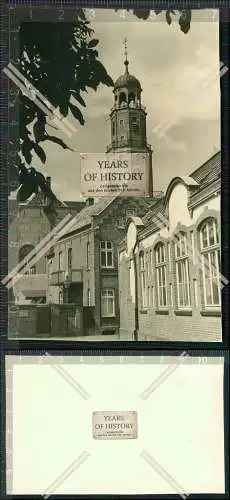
[[8, 177, 85, 304]]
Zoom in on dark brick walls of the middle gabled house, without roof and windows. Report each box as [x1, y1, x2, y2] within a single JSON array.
[[48, 198, 149, 333]]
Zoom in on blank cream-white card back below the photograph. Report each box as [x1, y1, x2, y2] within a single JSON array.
[[6, 356, 225, 497]]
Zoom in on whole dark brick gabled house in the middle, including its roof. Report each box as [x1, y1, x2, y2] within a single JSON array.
[[47, 197, 155, 335]]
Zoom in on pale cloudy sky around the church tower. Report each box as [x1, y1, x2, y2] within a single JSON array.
[[24, 9, 220, 200]]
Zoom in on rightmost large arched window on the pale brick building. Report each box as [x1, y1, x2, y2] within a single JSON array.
[[199, 218, 220, 307]]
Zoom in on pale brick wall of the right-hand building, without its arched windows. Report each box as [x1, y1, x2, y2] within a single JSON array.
[[119, 183, 221, 341]]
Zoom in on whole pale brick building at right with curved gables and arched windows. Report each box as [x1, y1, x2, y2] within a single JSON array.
[[119, 153, 221, 341]]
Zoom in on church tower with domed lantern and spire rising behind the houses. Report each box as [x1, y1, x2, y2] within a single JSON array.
[[106, 39, 153, 197]]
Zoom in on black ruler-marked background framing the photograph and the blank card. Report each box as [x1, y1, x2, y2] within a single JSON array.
[[0, 0, 230, 500]]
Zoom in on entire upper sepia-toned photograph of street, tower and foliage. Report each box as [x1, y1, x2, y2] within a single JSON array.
[[6, 9, 228, 342]]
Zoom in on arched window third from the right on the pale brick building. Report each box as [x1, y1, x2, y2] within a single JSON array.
[[155, 243, 168, 308]]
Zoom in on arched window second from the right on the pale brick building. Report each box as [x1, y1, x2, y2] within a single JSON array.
[[174, 233, 191, 309]]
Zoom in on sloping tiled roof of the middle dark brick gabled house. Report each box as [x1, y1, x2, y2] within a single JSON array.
[[59, 197, 116, 238]]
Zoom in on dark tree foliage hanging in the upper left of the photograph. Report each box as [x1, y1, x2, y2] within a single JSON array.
[[11, 10, 113, 205]]
